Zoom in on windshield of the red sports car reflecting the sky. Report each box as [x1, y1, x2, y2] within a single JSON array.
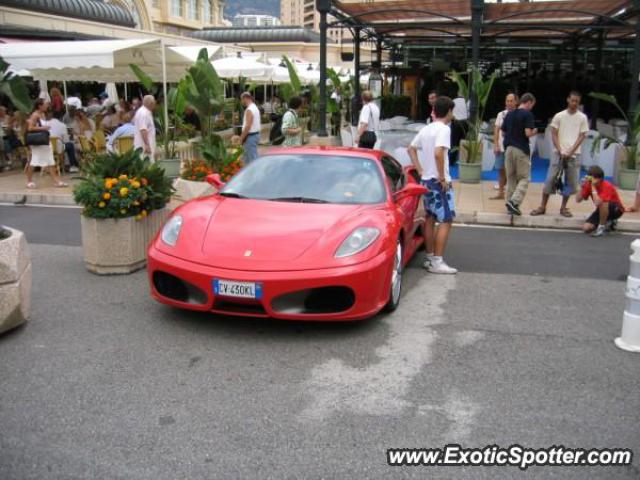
[[221, 153, 386, 204]]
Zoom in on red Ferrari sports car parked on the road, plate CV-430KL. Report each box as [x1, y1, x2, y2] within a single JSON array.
[[148, 147, 427, 320]]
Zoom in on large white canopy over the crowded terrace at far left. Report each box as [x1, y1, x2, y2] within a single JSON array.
[[0, 39, 220, 83]]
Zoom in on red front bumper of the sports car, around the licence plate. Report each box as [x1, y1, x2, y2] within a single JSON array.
[[147, 244, 394, 321]]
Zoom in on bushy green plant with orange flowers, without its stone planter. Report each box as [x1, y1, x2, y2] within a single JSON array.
[[73, 149, 173, 220]]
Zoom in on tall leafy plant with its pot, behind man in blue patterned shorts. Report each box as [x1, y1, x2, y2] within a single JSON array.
[[449, 67, 497, 183]]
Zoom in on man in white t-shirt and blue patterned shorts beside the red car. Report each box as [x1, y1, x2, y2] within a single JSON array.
[[408, 96, 457, 274]]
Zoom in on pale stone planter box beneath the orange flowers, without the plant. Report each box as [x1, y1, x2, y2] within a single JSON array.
[[81, 208, 170, 275]]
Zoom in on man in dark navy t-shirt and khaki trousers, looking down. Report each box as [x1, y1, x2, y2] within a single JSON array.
[[501, 93, 538, 215]]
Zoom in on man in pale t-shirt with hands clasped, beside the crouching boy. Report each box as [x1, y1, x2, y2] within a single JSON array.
[[531, 91, 589, 217]]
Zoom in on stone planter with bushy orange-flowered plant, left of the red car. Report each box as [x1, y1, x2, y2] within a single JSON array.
[[73, 149, 173, 275]]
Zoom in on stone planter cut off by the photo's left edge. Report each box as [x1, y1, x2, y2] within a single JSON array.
[[0, 227, 31, 333]]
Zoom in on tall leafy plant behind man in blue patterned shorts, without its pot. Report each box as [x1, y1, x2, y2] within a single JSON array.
[[449, 67, 497, 163]]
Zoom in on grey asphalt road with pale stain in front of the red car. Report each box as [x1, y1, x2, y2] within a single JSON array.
[[0, 207, 640, 480]]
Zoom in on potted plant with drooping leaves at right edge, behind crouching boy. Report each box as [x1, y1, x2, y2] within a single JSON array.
[[589, 92, 640, 190]]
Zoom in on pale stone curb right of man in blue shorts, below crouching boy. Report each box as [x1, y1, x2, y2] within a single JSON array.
[[454, 211, 640, 232]]
